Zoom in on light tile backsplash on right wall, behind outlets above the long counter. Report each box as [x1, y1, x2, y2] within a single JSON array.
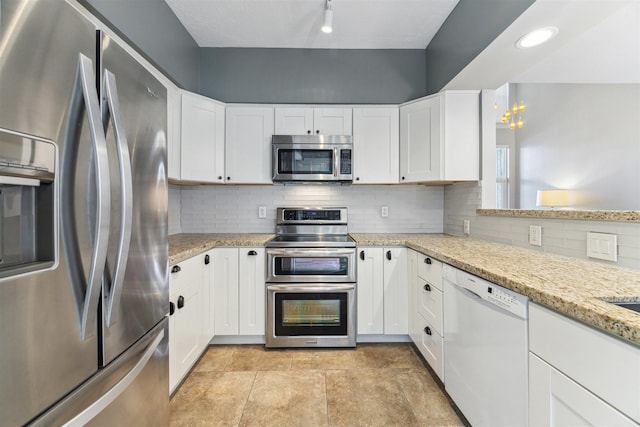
[[444, 183, 640, 270]]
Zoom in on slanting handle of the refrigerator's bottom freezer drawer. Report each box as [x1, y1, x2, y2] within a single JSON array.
[[65, 329, 164, 427]]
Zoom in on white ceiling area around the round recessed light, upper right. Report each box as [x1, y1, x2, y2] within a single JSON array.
[[444, 0, 640, 89]]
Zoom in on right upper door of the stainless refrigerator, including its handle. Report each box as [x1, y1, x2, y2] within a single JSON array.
[[100, 35, 169, 366]]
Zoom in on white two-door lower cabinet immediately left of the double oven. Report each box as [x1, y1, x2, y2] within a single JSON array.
[[213, 248, 266, 335]]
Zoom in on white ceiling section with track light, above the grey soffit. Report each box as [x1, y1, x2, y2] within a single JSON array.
[[165, 0, 458, 49]]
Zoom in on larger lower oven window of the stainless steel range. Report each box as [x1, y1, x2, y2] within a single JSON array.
[[275, 291, 349, 336]]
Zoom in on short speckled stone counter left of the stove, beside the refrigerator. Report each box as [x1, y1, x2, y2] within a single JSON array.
[[169, 233, 273, 265]]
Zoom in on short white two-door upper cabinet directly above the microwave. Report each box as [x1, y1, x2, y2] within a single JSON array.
[[275, 107, 352, 135]]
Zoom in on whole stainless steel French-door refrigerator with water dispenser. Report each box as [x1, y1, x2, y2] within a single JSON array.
[[0, 0, 169, 426]]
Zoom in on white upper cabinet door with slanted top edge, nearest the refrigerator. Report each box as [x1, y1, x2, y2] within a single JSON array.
[[180, 92, 224, 183]]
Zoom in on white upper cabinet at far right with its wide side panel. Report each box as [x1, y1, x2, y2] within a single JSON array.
[[400, 91, 480, 182]]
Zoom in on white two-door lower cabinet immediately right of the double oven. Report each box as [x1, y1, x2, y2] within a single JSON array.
[[356, 247, 409, 335]]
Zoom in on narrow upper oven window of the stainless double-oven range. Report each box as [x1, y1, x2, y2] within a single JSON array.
[[274, 256, 349, 276]]
